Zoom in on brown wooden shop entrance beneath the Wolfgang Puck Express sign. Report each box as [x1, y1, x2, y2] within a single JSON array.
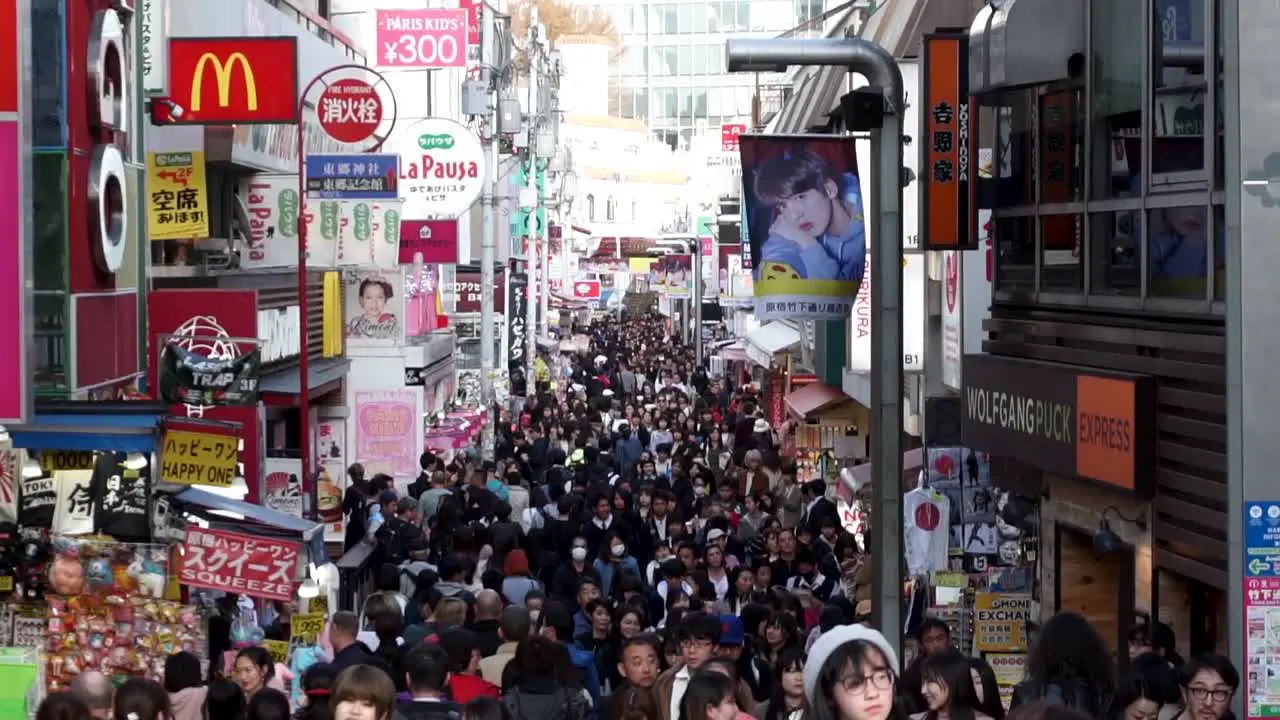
[[1053, 523, 1135, 664]]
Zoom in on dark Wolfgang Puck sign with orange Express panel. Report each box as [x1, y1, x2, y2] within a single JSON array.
[[960, 355, 1156, 496]]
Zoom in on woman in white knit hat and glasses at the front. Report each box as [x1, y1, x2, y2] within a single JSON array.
[[804, 625, 906, 720]]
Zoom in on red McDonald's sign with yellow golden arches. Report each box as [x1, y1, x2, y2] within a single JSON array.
[[169, 37, 298, 126]]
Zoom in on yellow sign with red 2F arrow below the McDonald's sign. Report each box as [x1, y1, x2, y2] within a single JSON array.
[[147, 151, 209, 240]]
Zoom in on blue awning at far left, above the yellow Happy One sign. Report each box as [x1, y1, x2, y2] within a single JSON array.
[[6, 404, 164, 454]]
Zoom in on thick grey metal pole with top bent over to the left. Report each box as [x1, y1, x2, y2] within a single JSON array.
[[724, 37, 904, 651]]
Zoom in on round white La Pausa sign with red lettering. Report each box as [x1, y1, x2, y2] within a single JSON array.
[[383, 118, 486, 220]]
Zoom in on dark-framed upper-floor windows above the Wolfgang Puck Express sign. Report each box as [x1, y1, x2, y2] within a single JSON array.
[[975, 0, 1226, 314]]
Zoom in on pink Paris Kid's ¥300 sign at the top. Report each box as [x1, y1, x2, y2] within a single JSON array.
[[378, 8, 467, 69]]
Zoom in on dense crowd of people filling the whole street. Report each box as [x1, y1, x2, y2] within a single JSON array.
[[32, 316, 1240, 720]]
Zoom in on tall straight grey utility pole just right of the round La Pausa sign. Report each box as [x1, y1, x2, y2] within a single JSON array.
[[480, 3, 498, 460]]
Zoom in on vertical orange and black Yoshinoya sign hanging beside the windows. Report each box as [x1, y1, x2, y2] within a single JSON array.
[[919, 32, 978, 250]]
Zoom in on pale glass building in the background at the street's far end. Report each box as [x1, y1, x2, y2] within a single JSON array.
[[596, 0, 824, 147]]
